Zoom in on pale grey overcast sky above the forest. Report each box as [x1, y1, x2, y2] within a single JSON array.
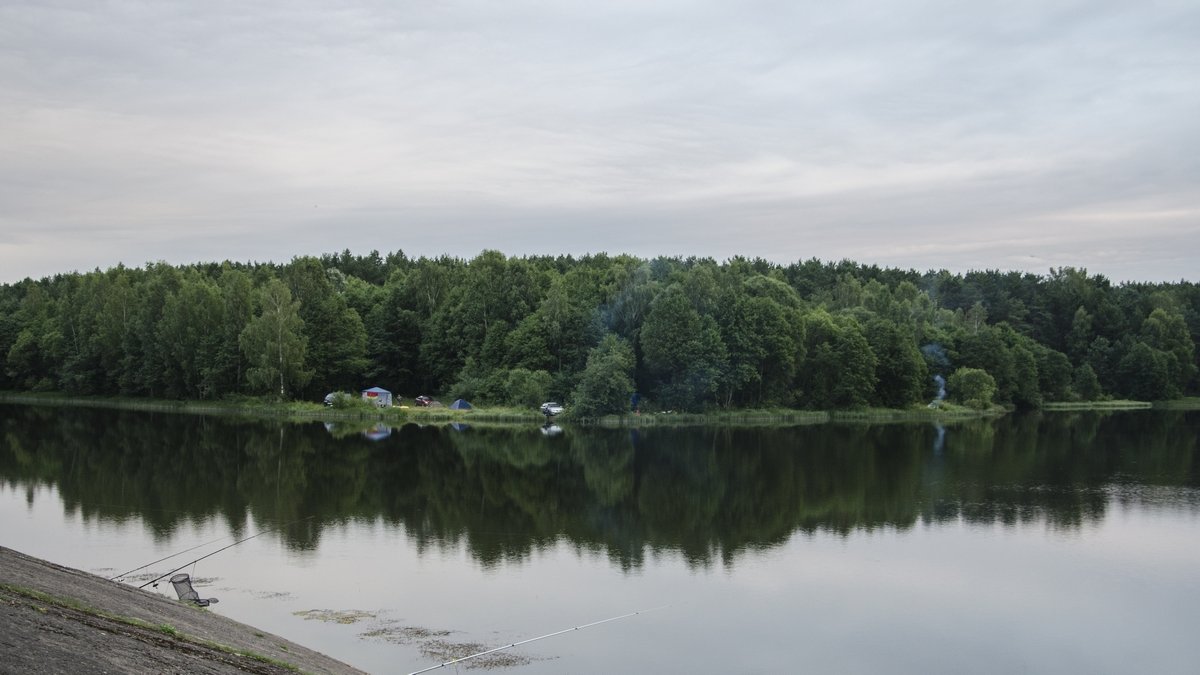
[[0, 0, 1200, 282]]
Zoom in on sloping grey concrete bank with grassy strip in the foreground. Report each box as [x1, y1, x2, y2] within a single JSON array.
[[0, 546, 362, 674]]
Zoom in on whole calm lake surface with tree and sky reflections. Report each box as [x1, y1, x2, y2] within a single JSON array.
[[0, 406, 1200, 674]]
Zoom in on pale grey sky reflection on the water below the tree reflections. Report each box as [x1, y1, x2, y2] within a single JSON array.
[[0, 478, 1200, 673]]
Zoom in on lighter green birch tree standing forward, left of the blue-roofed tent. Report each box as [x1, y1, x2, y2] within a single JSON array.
[[240, 279, 312, 399]]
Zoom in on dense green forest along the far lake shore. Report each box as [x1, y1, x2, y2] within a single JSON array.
[[0, 251, 1200, 416]]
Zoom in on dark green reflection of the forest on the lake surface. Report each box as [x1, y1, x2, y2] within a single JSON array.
[[0, 406, 1200, 569]]
